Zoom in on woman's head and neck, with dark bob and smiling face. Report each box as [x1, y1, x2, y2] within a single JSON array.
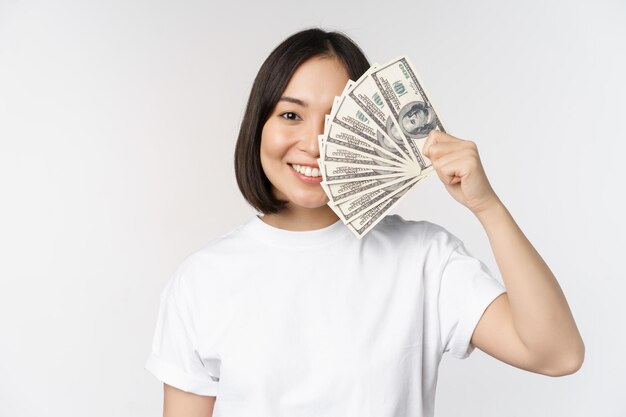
[[235, 29, 370, 230]]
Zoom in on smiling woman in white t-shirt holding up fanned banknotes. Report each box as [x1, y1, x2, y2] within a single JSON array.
[[146, 29, 584, 417]]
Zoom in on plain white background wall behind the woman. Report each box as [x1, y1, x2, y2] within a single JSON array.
[[0, 0, 626, 417]]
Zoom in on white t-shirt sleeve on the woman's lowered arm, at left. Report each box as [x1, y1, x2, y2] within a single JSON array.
[[145, 270, 219, 396]]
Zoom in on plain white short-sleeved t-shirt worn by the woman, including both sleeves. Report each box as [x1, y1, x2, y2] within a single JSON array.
[[145, 215, 505, 417]]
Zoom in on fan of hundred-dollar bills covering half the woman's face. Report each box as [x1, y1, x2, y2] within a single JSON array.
[[317, 56, 445, 239]]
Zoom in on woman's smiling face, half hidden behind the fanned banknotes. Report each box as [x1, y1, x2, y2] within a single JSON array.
[[261, 57, 349, 208]]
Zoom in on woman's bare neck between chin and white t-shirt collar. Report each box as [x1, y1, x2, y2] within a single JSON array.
[[261, 204, 339, 232]]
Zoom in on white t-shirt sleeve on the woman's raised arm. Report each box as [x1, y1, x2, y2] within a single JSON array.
[[438, 243, 506, 359]]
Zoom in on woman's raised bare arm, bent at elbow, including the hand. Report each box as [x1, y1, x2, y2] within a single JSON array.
[[424, 130, 585, 376]]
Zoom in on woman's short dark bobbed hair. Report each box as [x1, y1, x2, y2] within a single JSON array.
[[235, 28, 370, 214]]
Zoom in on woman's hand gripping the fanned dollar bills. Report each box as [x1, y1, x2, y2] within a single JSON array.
[[422, 129, 500, 215]]
